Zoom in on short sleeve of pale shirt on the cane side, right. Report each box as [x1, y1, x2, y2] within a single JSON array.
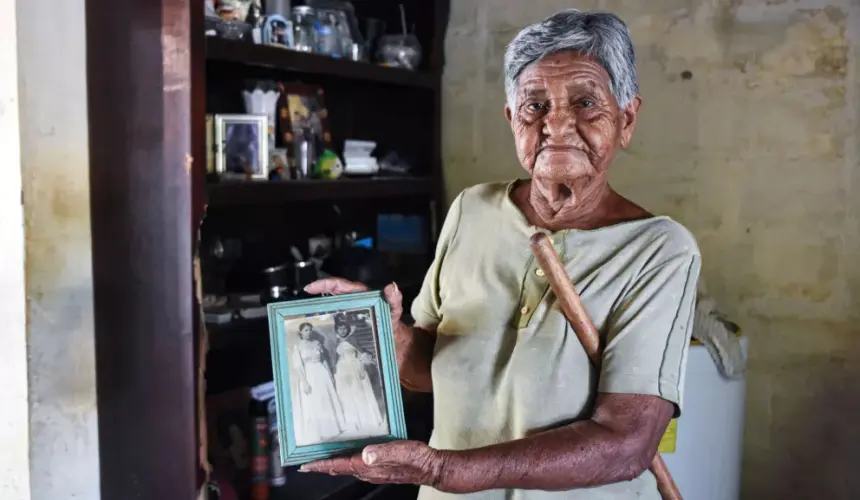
[[598, 253, 701, 417]]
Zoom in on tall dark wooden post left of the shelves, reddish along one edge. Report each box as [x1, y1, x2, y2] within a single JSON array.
[[86, 0, 197, 500]]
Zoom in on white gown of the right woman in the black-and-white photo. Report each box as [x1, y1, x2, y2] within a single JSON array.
[[335, 341, 387, 436]]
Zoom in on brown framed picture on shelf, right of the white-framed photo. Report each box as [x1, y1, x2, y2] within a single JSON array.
[[278, 83, 331, 173]]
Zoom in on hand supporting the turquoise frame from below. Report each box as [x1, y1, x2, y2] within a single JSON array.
[[299, 441, 445, 491]]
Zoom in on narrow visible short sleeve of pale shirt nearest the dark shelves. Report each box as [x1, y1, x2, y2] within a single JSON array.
[[411, 193, 463, 330]]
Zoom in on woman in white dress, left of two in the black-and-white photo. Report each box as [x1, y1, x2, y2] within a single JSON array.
[[291, 323, 344, 446]]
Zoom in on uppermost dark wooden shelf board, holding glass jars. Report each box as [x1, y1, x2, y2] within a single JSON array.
[[206, 36, 438, 89]]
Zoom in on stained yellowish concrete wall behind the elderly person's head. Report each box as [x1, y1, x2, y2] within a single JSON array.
[[444, 0, 860, 500]]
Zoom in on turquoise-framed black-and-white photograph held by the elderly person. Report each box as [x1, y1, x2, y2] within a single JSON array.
[[268, 292, 406, 465]]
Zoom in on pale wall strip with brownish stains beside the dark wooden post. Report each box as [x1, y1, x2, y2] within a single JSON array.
[[15, 0, 100, 500]]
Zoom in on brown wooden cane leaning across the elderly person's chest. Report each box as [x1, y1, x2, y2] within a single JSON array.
[[531, 233, 682, 500]]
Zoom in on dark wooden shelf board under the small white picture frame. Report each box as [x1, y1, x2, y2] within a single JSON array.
[[206, 177, 433, 206]]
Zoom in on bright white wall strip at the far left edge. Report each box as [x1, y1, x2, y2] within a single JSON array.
[[0, 0, 30, 500]]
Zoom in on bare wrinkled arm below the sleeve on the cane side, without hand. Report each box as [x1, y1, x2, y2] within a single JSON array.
[[435, 394, 674, 493]]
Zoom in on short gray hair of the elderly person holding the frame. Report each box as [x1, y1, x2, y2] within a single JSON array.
[[505, 9, 639, 109]]
